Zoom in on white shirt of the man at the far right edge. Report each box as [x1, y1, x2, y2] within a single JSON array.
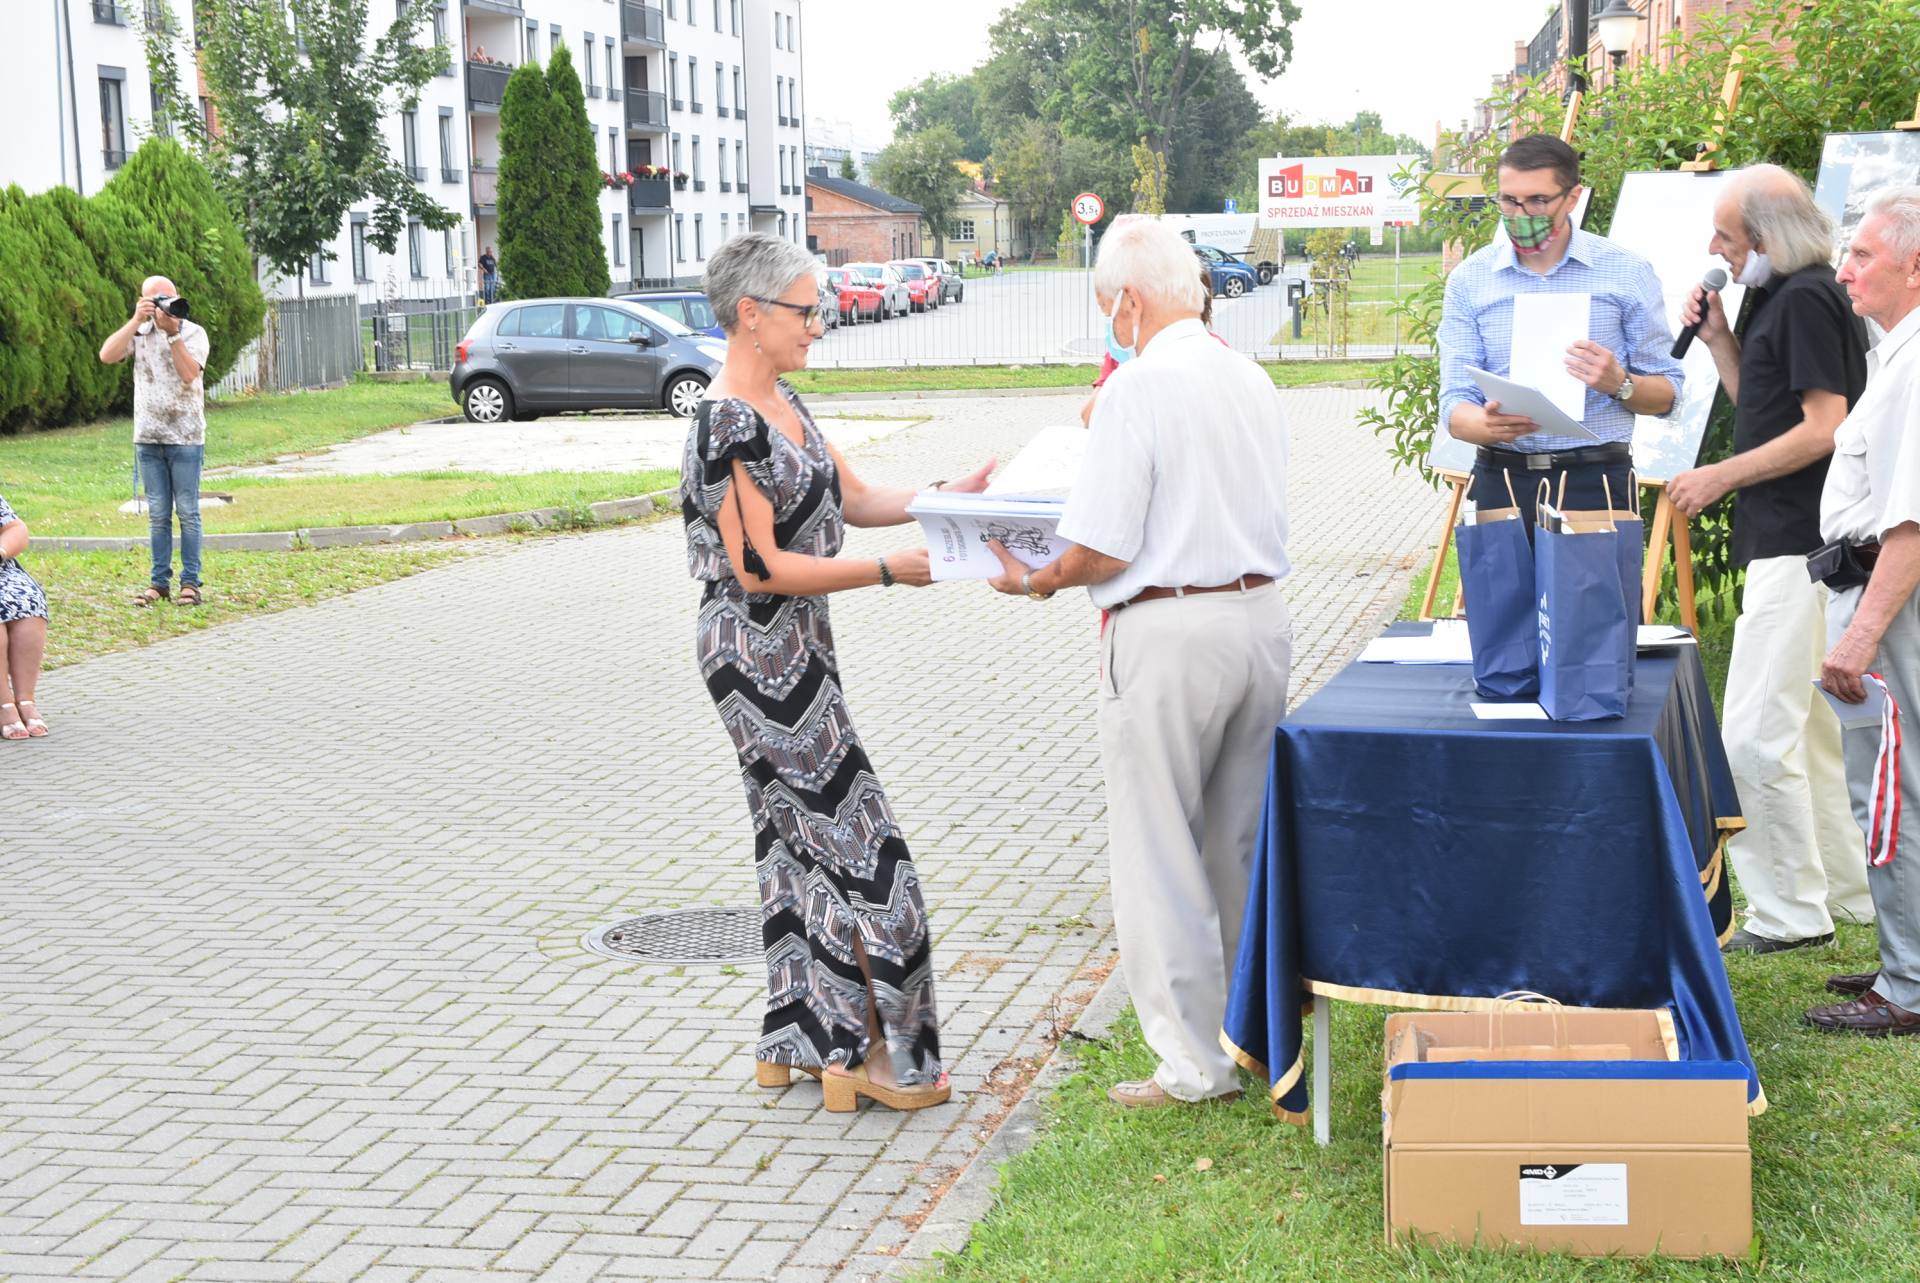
[[1820, 307, 1920, 542]]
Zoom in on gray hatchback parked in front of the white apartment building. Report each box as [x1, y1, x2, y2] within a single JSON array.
[[447, 298, 726, 423]]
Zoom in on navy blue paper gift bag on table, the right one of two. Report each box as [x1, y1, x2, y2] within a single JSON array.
[[1534, 478, 1640, 722]]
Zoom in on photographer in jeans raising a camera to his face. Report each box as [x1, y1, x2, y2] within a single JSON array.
[[100, 277, 207, 605]]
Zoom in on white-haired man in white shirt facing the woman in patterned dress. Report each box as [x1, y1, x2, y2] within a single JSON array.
[[993, 217, 1292, 1106]]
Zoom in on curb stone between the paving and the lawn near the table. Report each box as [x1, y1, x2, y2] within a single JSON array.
[[835, 960, 1127, 1283]]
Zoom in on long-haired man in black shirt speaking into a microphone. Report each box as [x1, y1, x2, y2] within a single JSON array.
[[1668, 165, 1874, 953]]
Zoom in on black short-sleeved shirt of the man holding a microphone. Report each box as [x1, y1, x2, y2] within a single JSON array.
[[1734, 263, 1866, 567]]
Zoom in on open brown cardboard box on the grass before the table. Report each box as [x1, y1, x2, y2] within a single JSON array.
[[1380, 1006, 1753, 1258]]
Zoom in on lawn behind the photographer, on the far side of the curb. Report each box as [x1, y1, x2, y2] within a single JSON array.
[[0, 380, 676, 536]]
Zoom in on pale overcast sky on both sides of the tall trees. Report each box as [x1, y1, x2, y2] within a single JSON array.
[[803, 0, 1551, 144]]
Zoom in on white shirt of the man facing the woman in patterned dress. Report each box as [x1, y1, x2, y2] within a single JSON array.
[[1060, 319, 1288, 609]]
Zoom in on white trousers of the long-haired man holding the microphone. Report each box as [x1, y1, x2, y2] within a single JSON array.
[[1724, 557, 1874, 939]]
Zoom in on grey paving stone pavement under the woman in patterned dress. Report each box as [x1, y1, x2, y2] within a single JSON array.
[[0, 390, 1440, 1283]]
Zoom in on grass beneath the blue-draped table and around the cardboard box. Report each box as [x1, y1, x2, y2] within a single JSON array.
[[922, 541, 1920, 1283]]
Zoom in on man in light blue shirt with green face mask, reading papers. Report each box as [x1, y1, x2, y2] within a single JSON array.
[[1440, 134, 1684, 538]]
